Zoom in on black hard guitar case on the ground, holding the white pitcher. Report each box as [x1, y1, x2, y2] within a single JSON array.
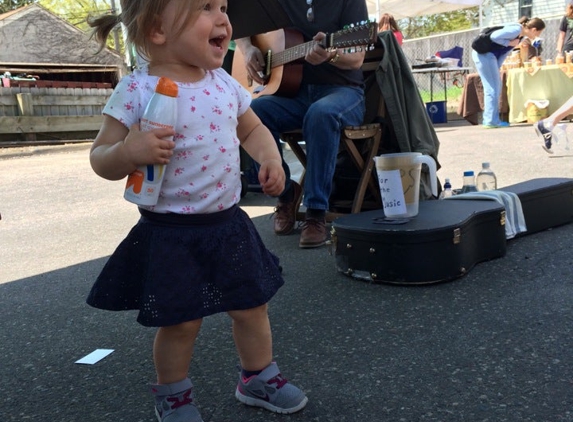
[[331, 178, 573, 285]]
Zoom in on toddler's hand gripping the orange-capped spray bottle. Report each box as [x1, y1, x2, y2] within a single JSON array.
[[123, 124, 175, 167]]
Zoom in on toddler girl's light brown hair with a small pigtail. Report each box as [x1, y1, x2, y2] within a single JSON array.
[[87, 0, 207, 58]]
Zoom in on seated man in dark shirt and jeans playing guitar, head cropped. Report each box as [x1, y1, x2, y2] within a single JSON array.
[[237, 0, 368, 248]]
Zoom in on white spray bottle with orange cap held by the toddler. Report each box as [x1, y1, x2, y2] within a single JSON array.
[[123, 77, 178, 206]]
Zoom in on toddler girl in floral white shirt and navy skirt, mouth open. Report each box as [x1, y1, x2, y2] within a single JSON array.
[[87, 0, 307, 422]]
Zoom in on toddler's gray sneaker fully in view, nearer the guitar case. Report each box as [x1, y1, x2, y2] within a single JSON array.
[[235, 362, 308, 413]]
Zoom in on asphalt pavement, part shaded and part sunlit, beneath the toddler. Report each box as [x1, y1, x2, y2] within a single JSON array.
[[0, 116, 573, 422]]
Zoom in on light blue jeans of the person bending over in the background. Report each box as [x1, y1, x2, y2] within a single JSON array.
[[472, 50, 507, 126]]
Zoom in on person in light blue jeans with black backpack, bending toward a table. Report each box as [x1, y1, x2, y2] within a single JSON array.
[[472, 16, 545, 128]]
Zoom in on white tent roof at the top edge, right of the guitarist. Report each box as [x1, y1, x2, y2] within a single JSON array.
[[366, 0, 483, 19]]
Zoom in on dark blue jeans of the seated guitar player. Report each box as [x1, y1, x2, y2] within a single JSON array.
[[251, 85, 365, 210]]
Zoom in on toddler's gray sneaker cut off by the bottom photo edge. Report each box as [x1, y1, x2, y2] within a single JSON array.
[[151, 378, 203, 422]]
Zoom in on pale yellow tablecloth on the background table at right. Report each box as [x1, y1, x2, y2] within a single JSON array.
[[507, 65, 573, 123]]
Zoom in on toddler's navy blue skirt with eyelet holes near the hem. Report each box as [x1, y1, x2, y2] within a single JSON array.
[[87, 206, 284, 327]]
